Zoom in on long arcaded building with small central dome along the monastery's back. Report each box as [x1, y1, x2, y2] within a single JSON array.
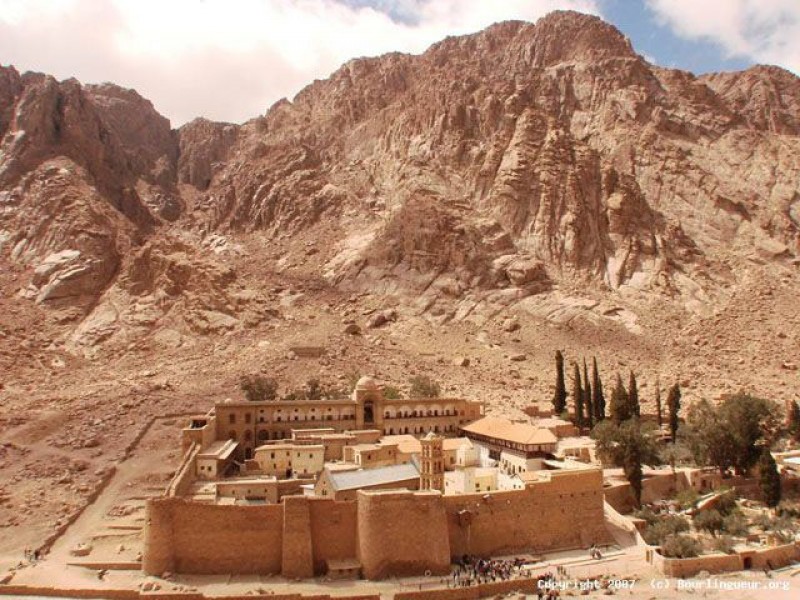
[[184, 377, 483, 461]]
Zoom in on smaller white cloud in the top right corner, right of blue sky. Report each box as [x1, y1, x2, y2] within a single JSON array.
[[647, 0, 800, 74]]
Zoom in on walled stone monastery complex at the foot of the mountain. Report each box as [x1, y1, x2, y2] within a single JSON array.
[[143, 377, 609, 579]]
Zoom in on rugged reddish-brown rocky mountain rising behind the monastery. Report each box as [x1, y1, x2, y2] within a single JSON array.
[[0, 12, 800, 398]]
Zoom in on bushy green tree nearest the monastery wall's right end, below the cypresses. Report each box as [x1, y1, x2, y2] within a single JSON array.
[[592, 419, 659, 505]]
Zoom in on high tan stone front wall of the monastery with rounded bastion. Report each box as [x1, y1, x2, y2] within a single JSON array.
[[142, 470, 610, 579]]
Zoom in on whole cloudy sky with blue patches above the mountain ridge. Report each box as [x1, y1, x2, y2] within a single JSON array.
[[0, 0, 800, 126]]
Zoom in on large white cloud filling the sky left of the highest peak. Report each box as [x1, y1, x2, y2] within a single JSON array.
[[0, 0, 599, 124]]
